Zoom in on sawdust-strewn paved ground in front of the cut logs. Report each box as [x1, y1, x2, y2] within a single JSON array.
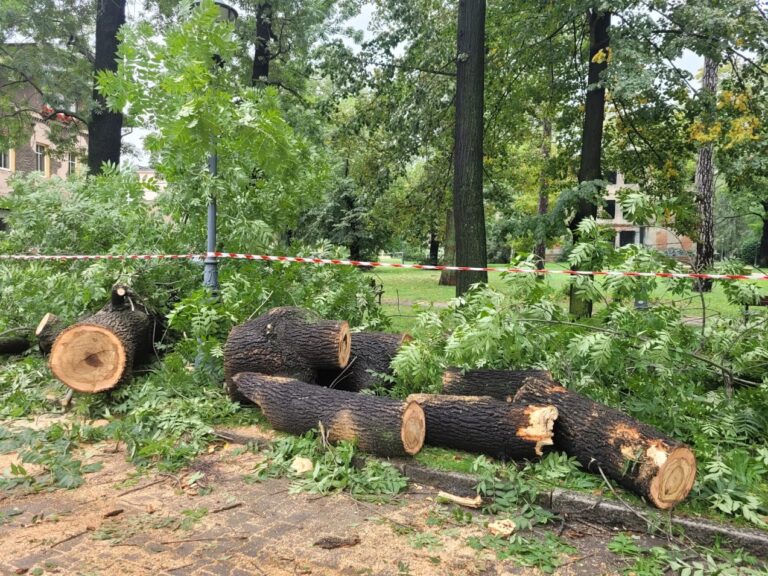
[[0, 429, 651, 576]]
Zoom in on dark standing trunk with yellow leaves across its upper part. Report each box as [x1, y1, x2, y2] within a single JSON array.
[[569, 8, 611, 318]]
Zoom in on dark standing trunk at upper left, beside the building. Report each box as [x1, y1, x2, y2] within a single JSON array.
[[88, 0, 126, 174]]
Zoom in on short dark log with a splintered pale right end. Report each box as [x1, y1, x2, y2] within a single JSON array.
[[408, 394, 557, 460]]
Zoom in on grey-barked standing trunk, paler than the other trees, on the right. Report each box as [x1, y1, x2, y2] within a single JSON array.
[[693, 57, 718, 292]]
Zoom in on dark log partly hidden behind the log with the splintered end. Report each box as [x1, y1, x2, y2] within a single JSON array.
[[443, 368, 552, 402]]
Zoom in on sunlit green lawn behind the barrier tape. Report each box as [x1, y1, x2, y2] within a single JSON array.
[[371, 258, 768, 331]]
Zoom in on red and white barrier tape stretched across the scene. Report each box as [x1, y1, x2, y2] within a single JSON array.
[[0, 252, 768, 280]]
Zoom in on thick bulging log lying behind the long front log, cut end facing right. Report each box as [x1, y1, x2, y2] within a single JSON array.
[[224, 307, 350, 400]]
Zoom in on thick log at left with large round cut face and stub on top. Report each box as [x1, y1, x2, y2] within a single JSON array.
[[49, 286, 154, 393]]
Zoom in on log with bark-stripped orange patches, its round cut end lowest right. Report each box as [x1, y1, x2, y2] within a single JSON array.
[[515, 380, 696, 510]]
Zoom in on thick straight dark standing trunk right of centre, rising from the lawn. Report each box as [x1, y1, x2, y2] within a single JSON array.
[[453, 0, 488, 296]]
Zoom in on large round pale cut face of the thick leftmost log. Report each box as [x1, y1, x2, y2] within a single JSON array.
[[50, 323, 126, 392]]
